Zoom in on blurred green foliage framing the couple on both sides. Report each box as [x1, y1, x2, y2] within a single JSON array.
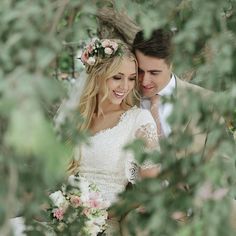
[[0, 0, 236, 236]]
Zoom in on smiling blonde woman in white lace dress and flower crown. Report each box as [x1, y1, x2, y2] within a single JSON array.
[[69, 39, 158, 235]]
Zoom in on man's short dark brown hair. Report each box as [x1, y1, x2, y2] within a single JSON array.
[[133, 29, 173, 63]]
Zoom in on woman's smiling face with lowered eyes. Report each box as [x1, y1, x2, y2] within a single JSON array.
[[107, 58, 136, 105]]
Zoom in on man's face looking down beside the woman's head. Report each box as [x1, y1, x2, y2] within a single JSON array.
[[135, 50, 171, 97]]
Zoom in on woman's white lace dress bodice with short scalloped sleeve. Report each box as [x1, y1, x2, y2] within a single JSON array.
[[75, 106, 158, 203]]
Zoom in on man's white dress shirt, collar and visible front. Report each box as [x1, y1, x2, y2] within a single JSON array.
[[141, 74, 176, 137]]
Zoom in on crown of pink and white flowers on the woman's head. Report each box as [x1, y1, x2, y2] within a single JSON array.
[[80, 39, 121, 66]]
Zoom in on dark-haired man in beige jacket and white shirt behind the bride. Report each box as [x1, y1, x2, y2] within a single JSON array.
[[133, 29, 220, 157]]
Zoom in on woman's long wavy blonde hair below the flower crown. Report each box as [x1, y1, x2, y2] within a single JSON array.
[[68, 39, 140, 173]]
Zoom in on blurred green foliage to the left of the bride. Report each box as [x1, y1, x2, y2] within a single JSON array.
[[0, 0, 96, 235]]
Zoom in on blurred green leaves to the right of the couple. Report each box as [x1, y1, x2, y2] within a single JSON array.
[[112, 0, 236, 236]]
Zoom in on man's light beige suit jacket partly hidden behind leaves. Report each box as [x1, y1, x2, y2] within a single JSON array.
[[172, 78, 215, 157]]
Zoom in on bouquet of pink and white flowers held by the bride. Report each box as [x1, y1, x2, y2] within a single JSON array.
[[49, 174, 110, 236]]
